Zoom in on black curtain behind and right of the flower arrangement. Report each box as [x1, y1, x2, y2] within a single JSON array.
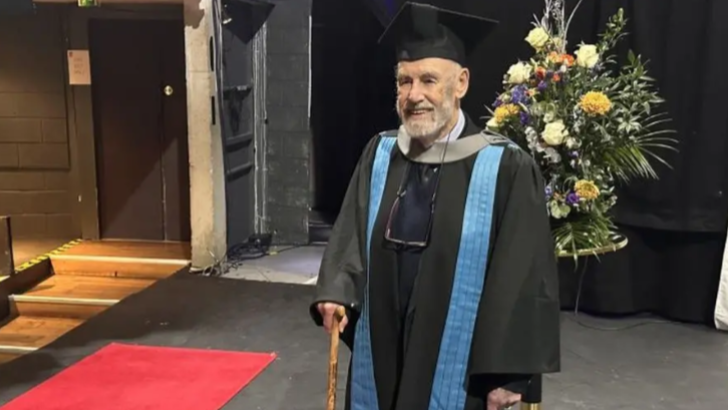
[[561, 0, 728, 326]]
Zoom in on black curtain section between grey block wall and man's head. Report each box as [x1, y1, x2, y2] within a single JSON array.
[[311, 0, 397, 220]]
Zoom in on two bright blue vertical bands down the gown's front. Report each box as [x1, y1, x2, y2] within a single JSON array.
[[350, 137, 503, 410]]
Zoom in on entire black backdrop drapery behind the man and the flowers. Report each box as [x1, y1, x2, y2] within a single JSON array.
[[313, 0, 728, 324]]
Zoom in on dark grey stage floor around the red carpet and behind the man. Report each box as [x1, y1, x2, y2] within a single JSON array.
[[0, 273, 728, 410]]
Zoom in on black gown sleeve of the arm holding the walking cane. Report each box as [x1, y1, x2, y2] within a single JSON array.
[[309, 137, 380, 327]]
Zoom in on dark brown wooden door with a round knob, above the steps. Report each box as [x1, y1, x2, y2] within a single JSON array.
[[89, 20, 190, 241]]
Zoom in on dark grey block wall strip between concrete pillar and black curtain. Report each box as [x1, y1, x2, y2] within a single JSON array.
[[266, 0, 311, 243]]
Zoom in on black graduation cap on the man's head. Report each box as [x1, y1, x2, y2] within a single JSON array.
[[379, 2, 498, 64]]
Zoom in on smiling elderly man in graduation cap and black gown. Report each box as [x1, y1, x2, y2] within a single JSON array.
[[311, 3, 560, 410]]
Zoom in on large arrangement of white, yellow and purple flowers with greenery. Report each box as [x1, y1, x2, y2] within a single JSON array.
[[487, 0, 674, 255]]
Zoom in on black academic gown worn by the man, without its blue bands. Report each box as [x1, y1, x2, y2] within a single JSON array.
[[310, 113, 560, 410]]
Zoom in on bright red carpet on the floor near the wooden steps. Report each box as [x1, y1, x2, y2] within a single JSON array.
[[0, 342, 275, 410]]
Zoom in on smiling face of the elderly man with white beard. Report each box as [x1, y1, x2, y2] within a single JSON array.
[[397, 58, 469, 141]]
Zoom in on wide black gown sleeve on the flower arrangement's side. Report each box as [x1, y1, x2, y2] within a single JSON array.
[[470, 149, 560, 394]]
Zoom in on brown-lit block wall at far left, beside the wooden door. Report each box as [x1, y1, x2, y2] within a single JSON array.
[[0, 8, 79, 237]]
